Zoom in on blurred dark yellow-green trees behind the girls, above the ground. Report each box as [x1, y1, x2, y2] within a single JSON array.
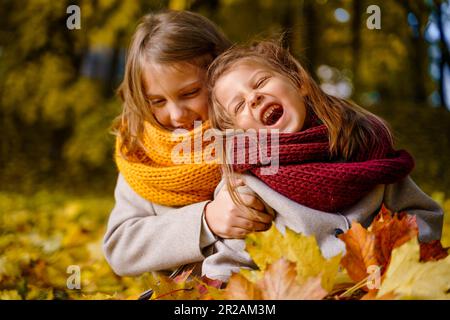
[[0, 0, 450, 193]]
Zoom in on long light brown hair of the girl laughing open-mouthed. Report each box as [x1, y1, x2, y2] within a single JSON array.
[[207, 41, 393, 215]]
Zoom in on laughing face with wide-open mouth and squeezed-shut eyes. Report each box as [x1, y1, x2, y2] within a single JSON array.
[[214, 62, 306, 132]]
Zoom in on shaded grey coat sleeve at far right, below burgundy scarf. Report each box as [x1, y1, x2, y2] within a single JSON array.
[[383, 176, 444, 242]]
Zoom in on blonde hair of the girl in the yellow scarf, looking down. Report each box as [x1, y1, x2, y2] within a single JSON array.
[[113, 10, 231, 157]]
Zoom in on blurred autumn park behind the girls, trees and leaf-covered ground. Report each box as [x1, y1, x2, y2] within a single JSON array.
[[0, 0, 450, 299]]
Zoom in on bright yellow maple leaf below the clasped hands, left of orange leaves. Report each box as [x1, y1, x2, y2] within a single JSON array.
[[243, 226, 341, 291]]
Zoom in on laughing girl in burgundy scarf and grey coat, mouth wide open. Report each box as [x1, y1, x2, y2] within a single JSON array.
[[203, 42, 443, 281]]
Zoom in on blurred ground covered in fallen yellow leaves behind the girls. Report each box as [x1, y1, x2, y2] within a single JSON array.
[[0, 191, 450, 299]]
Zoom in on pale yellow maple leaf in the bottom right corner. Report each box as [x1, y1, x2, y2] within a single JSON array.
[[377, 238, 450, 299]]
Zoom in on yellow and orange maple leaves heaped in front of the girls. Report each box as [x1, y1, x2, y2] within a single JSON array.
[[139, 206, 450, 300]]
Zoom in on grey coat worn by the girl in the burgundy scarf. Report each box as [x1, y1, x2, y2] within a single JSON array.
[[202, 174, 444, 281]]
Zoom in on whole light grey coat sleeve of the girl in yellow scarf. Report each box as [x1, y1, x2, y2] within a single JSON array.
[[103, 175, 213, 276]]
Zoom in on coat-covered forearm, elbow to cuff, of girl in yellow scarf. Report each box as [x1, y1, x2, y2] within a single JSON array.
[[104, 203, 211, 276]]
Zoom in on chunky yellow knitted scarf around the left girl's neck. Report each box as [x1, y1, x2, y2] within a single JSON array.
[[115, 122, 221, 207]]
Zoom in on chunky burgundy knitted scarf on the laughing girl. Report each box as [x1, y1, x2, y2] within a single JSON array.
[[233, 114, 414, 212]]
